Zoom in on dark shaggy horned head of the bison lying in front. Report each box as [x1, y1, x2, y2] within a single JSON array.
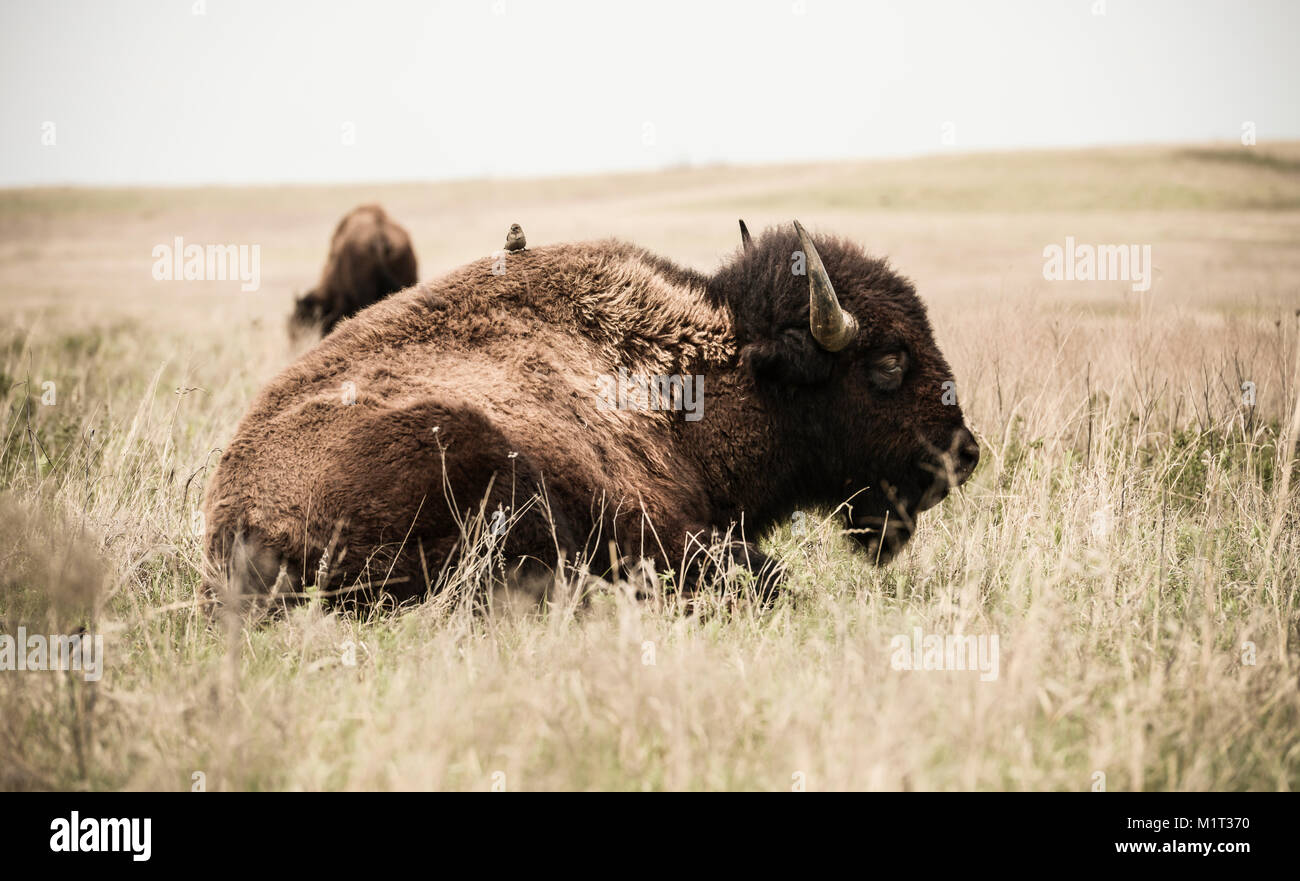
[[725, 221, 979, 563]]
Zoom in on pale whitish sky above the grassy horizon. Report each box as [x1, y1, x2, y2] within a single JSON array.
[[0, 0, 1300, 186]]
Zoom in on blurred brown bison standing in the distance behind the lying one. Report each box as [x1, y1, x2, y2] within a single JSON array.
[[289, 205, 416, 337]]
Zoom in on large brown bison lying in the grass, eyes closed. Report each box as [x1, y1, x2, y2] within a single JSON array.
[[205, 223, 979, 608]]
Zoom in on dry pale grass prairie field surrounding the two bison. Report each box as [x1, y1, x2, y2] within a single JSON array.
[[0, 143, 1300, 791]]
